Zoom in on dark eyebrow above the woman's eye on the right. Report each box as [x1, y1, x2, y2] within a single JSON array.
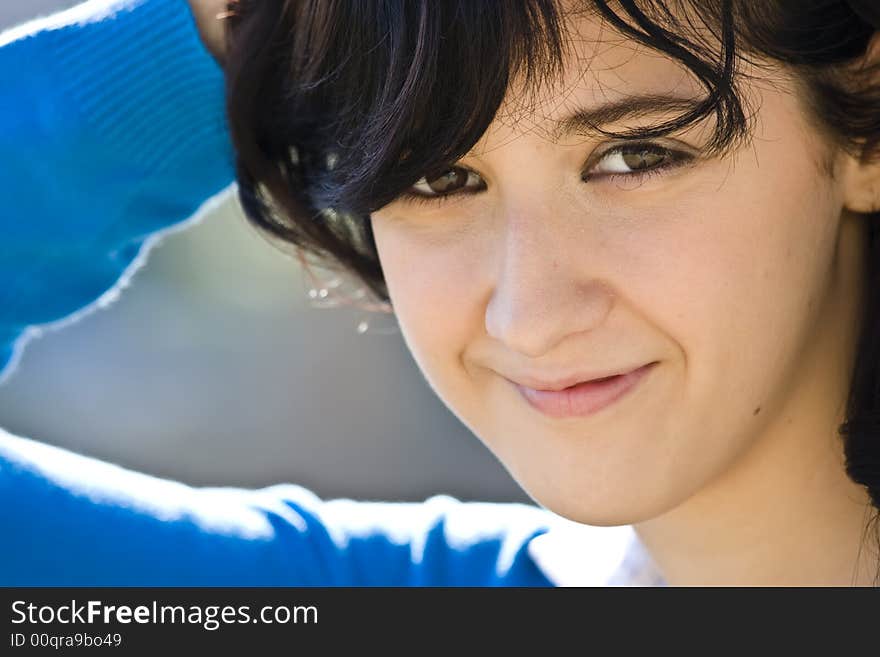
[[550, 94, 703, 141]]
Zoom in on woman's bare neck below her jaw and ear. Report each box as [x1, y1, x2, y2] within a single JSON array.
[[635, 210, 878, 586]]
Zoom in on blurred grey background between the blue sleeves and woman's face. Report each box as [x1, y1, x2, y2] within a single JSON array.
[[0, 0, 528, 502]]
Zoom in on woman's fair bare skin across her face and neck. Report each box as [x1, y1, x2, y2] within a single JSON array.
[[373, 11, 880, 585]]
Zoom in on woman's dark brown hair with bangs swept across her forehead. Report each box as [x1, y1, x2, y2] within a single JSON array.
[[227, 0, 880, 576]]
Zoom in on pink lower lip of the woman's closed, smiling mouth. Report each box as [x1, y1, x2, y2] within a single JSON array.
[[512, 361, 657, 418]]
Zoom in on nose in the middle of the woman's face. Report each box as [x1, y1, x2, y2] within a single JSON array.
[[485, 208, 614, 358]]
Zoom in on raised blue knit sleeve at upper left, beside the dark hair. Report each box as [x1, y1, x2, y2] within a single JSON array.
[[0, 0, 234, 374]]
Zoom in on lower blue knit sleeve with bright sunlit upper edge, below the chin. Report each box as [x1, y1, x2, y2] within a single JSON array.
[[0, 430, 551, 586]]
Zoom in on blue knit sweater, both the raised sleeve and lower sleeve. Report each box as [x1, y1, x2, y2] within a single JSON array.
[[0, 0, 554, 586]]
